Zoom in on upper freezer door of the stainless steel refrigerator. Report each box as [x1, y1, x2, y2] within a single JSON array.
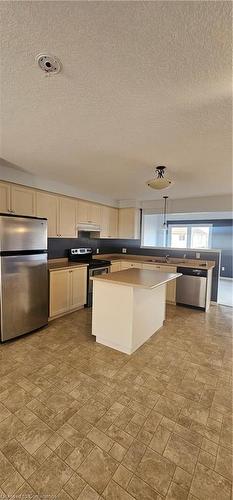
[[0, 215, 47, 253]]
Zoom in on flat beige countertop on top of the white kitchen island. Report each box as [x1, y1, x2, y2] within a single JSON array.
[[91, 268, 182, 289]]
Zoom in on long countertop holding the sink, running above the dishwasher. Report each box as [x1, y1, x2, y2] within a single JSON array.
[[93, 253, 215, 270]]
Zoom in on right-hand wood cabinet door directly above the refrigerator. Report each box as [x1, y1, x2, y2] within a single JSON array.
[[11, 184, 36, 216]]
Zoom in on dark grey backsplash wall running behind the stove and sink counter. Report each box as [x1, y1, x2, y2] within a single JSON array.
[[48, 238, 220, 301]]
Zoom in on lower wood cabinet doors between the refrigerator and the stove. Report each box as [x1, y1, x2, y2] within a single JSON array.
[[49, 267, 87, 318]]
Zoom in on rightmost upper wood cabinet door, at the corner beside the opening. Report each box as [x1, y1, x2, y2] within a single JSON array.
[[118, 208, 140, 239]]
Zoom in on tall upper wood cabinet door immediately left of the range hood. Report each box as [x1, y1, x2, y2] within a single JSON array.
[[59, 196, 77, 238]]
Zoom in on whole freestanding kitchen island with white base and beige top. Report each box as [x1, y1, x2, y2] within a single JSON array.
[[92, 268, 181, 354]]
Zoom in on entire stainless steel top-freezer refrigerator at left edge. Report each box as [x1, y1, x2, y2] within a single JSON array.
[[0, 214, 48, 342]]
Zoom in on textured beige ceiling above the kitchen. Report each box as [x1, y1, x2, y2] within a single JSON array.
[[1, 1, 231, 200]]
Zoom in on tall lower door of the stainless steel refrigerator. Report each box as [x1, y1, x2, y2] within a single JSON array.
[[0, 254, 48, 341]]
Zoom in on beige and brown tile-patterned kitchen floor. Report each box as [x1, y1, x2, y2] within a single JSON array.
[[0, 306, 232, 500]]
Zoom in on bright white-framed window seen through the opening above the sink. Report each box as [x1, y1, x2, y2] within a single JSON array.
[[168, 224, 212, 248]]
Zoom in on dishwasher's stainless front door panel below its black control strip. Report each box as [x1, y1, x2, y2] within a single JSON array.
[[176, 270, 207, 308]]
